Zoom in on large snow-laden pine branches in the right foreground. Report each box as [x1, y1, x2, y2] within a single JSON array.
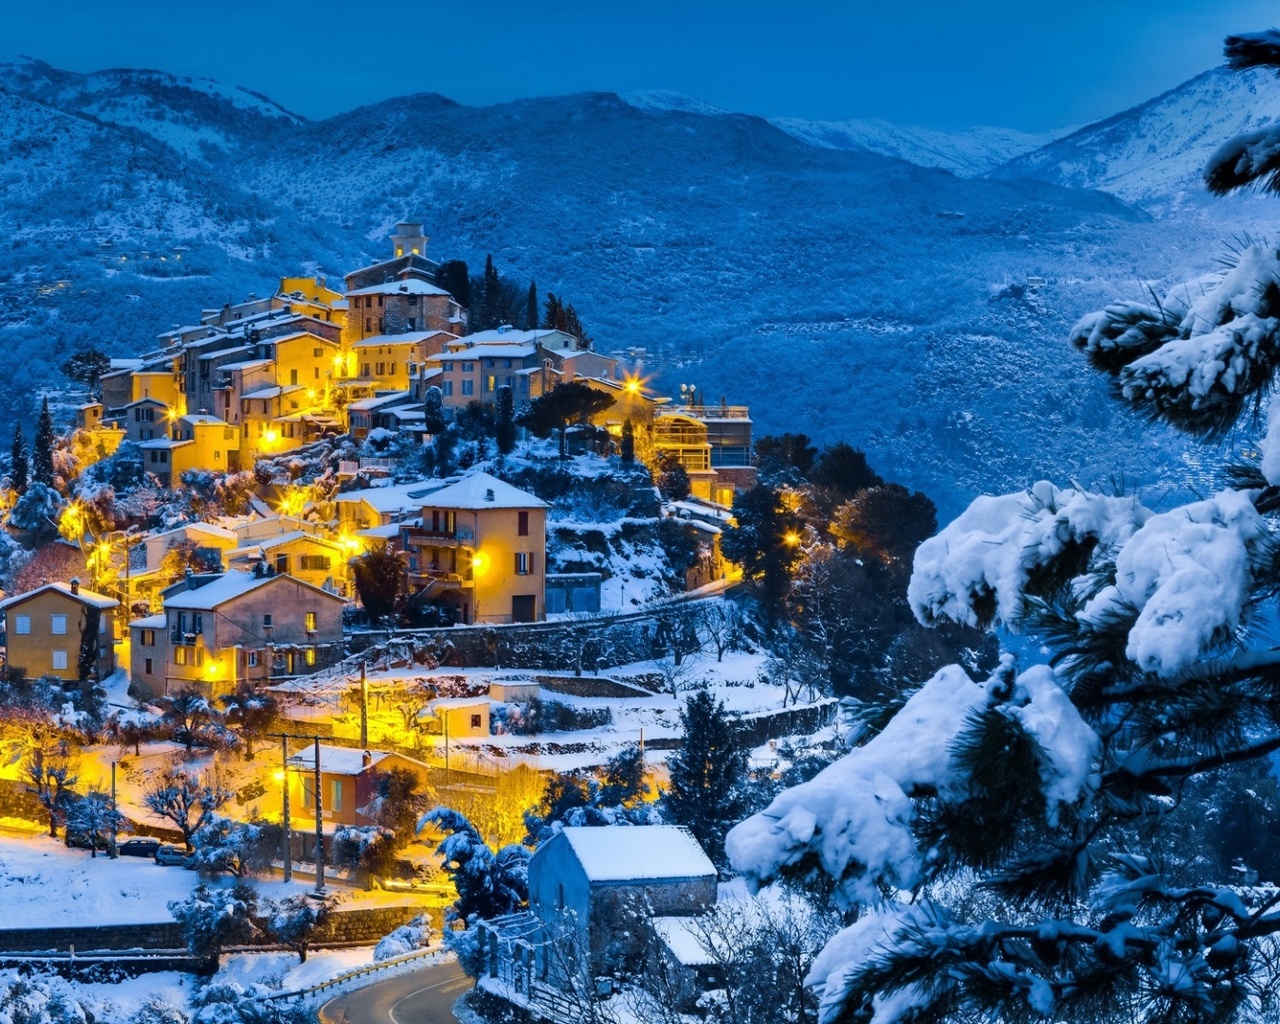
[[726, 31, 1280, 1024]]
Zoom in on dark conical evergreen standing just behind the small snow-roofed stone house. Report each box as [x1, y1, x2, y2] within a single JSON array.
[[663, 690, 746, 864]]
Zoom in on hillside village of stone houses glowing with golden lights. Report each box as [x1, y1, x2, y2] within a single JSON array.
[[0, 223, 880, 1009]]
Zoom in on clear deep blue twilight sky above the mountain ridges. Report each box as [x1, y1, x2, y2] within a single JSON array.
[[0, 0, 1280, 131]]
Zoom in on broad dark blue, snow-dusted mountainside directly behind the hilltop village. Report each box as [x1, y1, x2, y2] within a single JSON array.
[[0, 63, 1259, 511]]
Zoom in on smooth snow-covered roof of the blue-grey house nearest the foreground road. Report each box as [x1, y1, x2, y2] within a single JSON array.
[[560, 824, 716, 882]]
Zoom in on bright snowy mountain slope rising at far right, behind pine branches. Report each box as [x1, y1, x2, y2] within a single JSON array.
[[996, 68, 1280, 210]]
